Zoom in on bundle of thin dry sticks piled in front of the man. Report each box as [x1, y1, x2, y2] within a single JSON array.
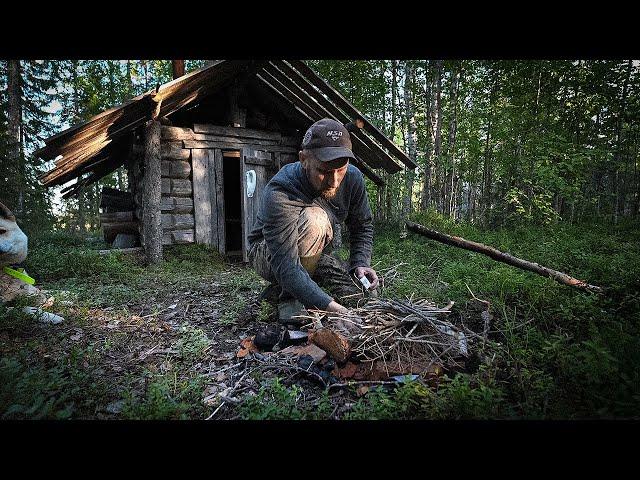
[[298, 298, 468, 374]]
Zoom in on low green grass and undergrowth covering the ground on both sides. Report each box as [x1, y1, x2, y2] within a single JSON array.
[[0, 218, 640, 420]]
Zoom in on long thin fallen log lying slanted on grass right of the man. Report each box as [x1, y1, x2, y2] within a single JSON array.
[[406, 222, 603, 293]]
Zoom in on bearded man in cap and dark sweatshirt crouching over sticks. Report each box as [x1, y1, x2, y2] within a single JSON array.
[[248, 118, 378, 323]]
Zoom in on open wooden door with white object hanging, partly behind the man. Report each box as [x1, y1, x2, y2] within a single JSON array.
[[241, 147, 279, 262]]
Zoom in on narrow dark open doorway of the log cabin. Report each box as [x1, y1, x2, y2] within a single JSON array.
[[222, 151, 242, 255]]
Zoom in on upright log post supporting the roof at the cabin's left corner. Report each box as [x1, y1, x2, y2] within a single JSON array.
[[142, 120, 162, 264]]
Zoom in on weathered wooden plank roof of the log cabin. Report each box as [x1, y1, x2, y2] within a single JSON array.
[[35, 60, 417, 196]]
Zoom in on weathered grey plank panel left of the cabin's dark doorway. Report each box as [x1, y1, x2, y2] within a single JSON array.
[[192, 148, 226, 254]]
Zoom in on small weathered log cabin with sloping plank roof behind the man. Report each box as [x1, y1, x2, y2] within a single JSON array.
[[36, 60, 416, 263]]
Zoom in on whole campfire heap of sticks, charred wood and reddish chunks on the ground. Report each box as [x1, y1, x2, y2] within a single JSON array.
[[237, 262, 493, 388]]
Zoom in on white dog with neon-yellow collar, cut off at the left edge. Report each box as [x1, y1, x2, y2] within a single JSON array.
[[0, 203, 63, 324]]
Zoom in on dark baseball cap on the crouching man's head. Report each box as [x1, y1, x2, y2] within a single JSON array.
[[302, 118, 356, 162]]
